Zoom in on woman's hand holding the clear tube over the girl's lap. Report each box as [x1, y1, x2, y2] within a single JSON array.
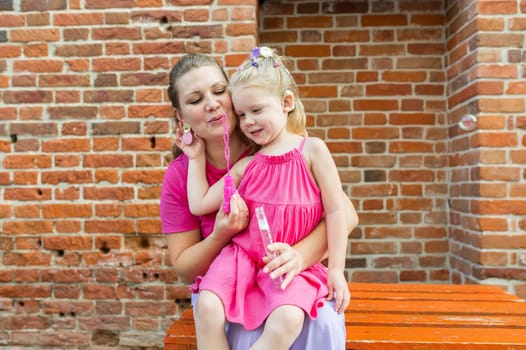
[[263, 242, 304, 289]]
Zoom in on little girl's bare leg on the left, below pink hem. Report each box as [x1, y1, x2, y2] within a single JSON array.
[[194, 290, 229, 350]]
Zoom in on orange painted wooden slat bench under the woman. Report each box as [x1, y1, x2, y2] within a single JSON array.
[[164, 283, 526, 350]]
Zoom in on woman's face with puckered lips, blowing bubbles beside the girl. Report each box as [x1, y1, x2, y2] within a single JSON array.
[[176, 66, 237, 141]]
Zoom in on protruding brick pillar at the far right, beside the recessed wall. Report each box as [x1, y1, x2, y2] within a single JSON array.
[[446, 1, 526, 298]]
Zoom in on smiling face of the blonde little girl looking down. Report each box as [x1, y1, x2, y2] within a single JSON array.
[[232, 86, 291, 145]]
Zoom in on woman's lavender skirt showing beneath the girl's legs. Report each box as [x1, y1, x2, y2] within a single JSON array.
[[192, 294, 346, 350]]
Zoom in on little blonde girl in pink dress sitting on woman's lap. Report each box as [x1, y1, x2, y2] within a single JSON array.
[[183, 47, 350, 350]]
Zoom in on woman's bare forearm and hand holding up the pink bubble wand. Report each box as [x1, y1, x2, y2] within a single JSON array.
[[167, 194, 252, 283]]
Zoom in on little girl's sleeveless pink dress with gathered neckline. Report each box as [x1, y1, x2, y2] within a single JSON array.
[[192, 139, 328, 330]]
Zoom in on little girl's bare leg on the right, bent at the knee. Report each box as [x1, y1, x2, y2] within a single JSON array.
[[250, 305, 305, 350]]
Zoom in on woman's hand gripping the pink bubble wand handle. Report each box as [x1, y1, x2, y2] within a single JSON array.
[[216, 192, 248, 240]]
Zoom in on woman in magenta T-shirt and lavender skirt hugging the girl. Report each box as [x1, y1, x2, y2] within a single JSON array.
[[161, 54, 358, 350]]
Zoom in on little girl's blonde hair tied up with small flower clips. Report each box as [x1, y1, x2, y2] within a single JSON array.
[[229, 46, 307, 136]]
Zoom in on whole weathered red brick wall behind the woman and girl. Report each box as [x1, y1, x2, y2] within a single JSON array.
[[0, 0, 526, 349]]
